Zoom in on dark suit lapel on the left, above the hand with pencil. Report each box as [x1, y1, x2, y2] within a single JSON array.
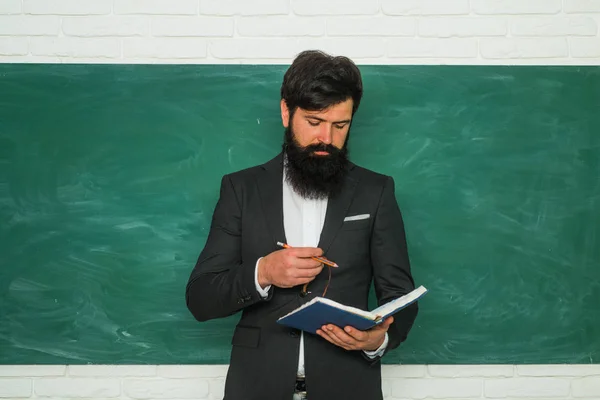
[[256, 154, 287, 246]]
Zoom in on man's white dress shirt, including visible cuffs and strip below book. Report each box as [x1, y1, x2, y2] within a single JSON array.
[[254, 168, 388, 376]]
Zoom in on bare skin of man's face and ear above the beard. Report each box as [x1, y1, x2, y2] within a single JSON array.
[[281, 99, 352, 153]]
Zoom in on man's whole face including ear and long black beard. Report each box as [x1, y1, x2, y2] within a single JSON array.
[[281, 100, 352, 199]]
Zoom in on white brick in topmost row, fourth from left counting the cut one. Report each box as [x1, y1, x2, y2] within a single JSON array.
[[200, 0, 290, 16]]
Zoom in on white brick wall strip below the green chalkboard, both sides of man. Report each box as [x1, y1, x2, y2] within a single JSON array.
[[0, 365, 600, 400]]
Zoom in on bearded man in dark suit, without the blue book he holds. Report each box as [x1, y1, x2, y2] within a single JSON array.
[[186, 51, 418, 400]]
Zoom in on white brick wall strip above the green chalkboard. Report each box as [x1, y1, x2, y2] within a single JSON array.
[[0, 0, 600, 65]]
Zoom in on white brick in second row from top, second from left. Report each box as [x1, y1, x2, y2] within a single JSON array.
[[62, 16, 150, 37]]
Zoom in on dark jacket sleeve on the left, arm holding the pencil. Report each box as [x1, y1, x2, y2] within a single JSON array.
[[185, 175, 273, 321]]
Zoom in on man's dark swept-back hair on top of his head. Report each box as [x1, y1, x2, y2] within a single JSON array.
[[281, 50, 363, 115]]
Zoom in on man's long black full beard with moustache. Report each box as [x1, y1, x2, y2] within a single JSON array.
[[283, 124, 348, 200]]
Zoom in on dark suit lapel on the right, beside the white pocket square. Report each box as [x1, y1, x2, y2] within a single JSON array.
[[318, 172, 357, 253]]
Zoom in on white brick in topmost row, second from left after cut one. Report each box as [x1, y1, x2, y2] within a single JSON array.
[[23, 0, 112, 15]]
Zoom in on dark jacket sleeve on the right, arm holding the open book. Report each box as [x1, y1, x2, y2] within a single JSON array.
[[365, 177, 418, 363]]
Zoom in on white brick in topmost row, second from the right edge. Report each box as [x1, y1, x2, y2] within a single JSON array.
[[471, 0, 562, 15]]
